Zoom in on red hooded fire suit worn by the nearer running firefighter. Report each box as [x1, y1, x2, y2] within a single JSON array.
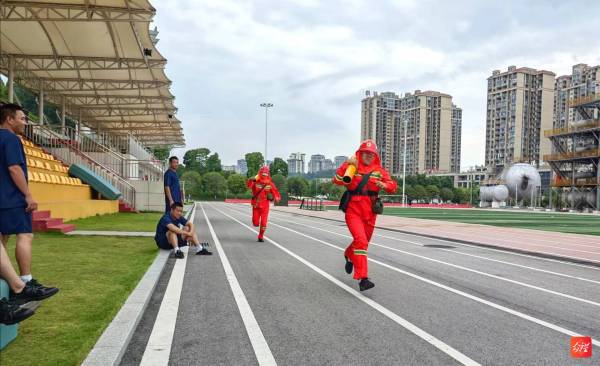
[[333, 140, 398, 280]]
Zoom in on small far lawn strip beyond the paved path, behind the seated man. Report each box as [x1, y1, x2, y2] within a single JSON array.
[[69, 212, 163, 231]]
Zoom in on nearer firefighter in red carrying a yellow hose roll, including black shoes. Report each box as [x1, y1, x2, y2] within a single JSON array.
[[333, 140, 398, 291]]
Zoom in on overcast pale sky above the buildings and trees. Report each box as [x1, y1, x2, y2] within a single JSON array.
[[153, 0, 600, 168]]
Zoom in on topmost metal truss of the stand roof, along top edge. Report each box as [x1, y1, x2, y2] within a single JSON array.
[[0, 0, 155, 22]]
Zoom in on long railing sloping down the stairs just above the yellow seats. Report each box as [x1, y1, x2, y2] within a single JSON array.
[[25, 124, 135, 207]]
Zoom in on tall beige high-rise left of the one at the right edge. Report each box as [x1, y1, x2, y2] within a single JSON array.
[[485, 66, 555, 174]]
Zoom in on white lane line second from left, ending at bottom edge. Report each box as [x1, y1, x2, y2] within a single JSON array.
[[200, 203, 277, 366]]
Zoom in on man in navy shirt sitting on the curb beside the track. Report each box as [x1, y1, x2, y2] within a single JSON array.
[[154, 202, 212, 259]]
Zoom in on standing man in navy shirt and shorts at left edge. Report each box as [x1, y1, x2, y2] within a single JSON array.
[[0, 104, 58, 296]]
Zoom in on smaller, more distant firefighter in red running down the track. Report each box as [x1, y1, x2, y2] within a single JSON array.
[[247, 166, 281, 242]]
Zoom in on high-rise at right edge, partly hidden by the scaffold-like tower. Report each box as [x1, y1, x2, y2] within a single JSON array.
[[553, 64, 600, 128]]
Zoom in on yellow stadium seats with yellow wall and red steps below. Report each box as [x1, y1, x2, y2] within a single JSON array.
[[21, 138, 119, 232]]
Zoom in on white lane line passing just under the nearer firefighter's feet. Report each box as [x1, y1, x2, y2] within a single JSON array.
[[212, 206, 479, 365]]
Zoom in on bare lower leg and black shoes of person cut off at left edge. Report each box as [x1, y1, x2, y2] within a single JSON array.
[[0, 245, 56, 325]]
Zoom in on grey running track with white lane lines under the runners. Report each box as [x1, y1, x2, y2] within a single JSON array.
[[122, 203, 600, 365]]
